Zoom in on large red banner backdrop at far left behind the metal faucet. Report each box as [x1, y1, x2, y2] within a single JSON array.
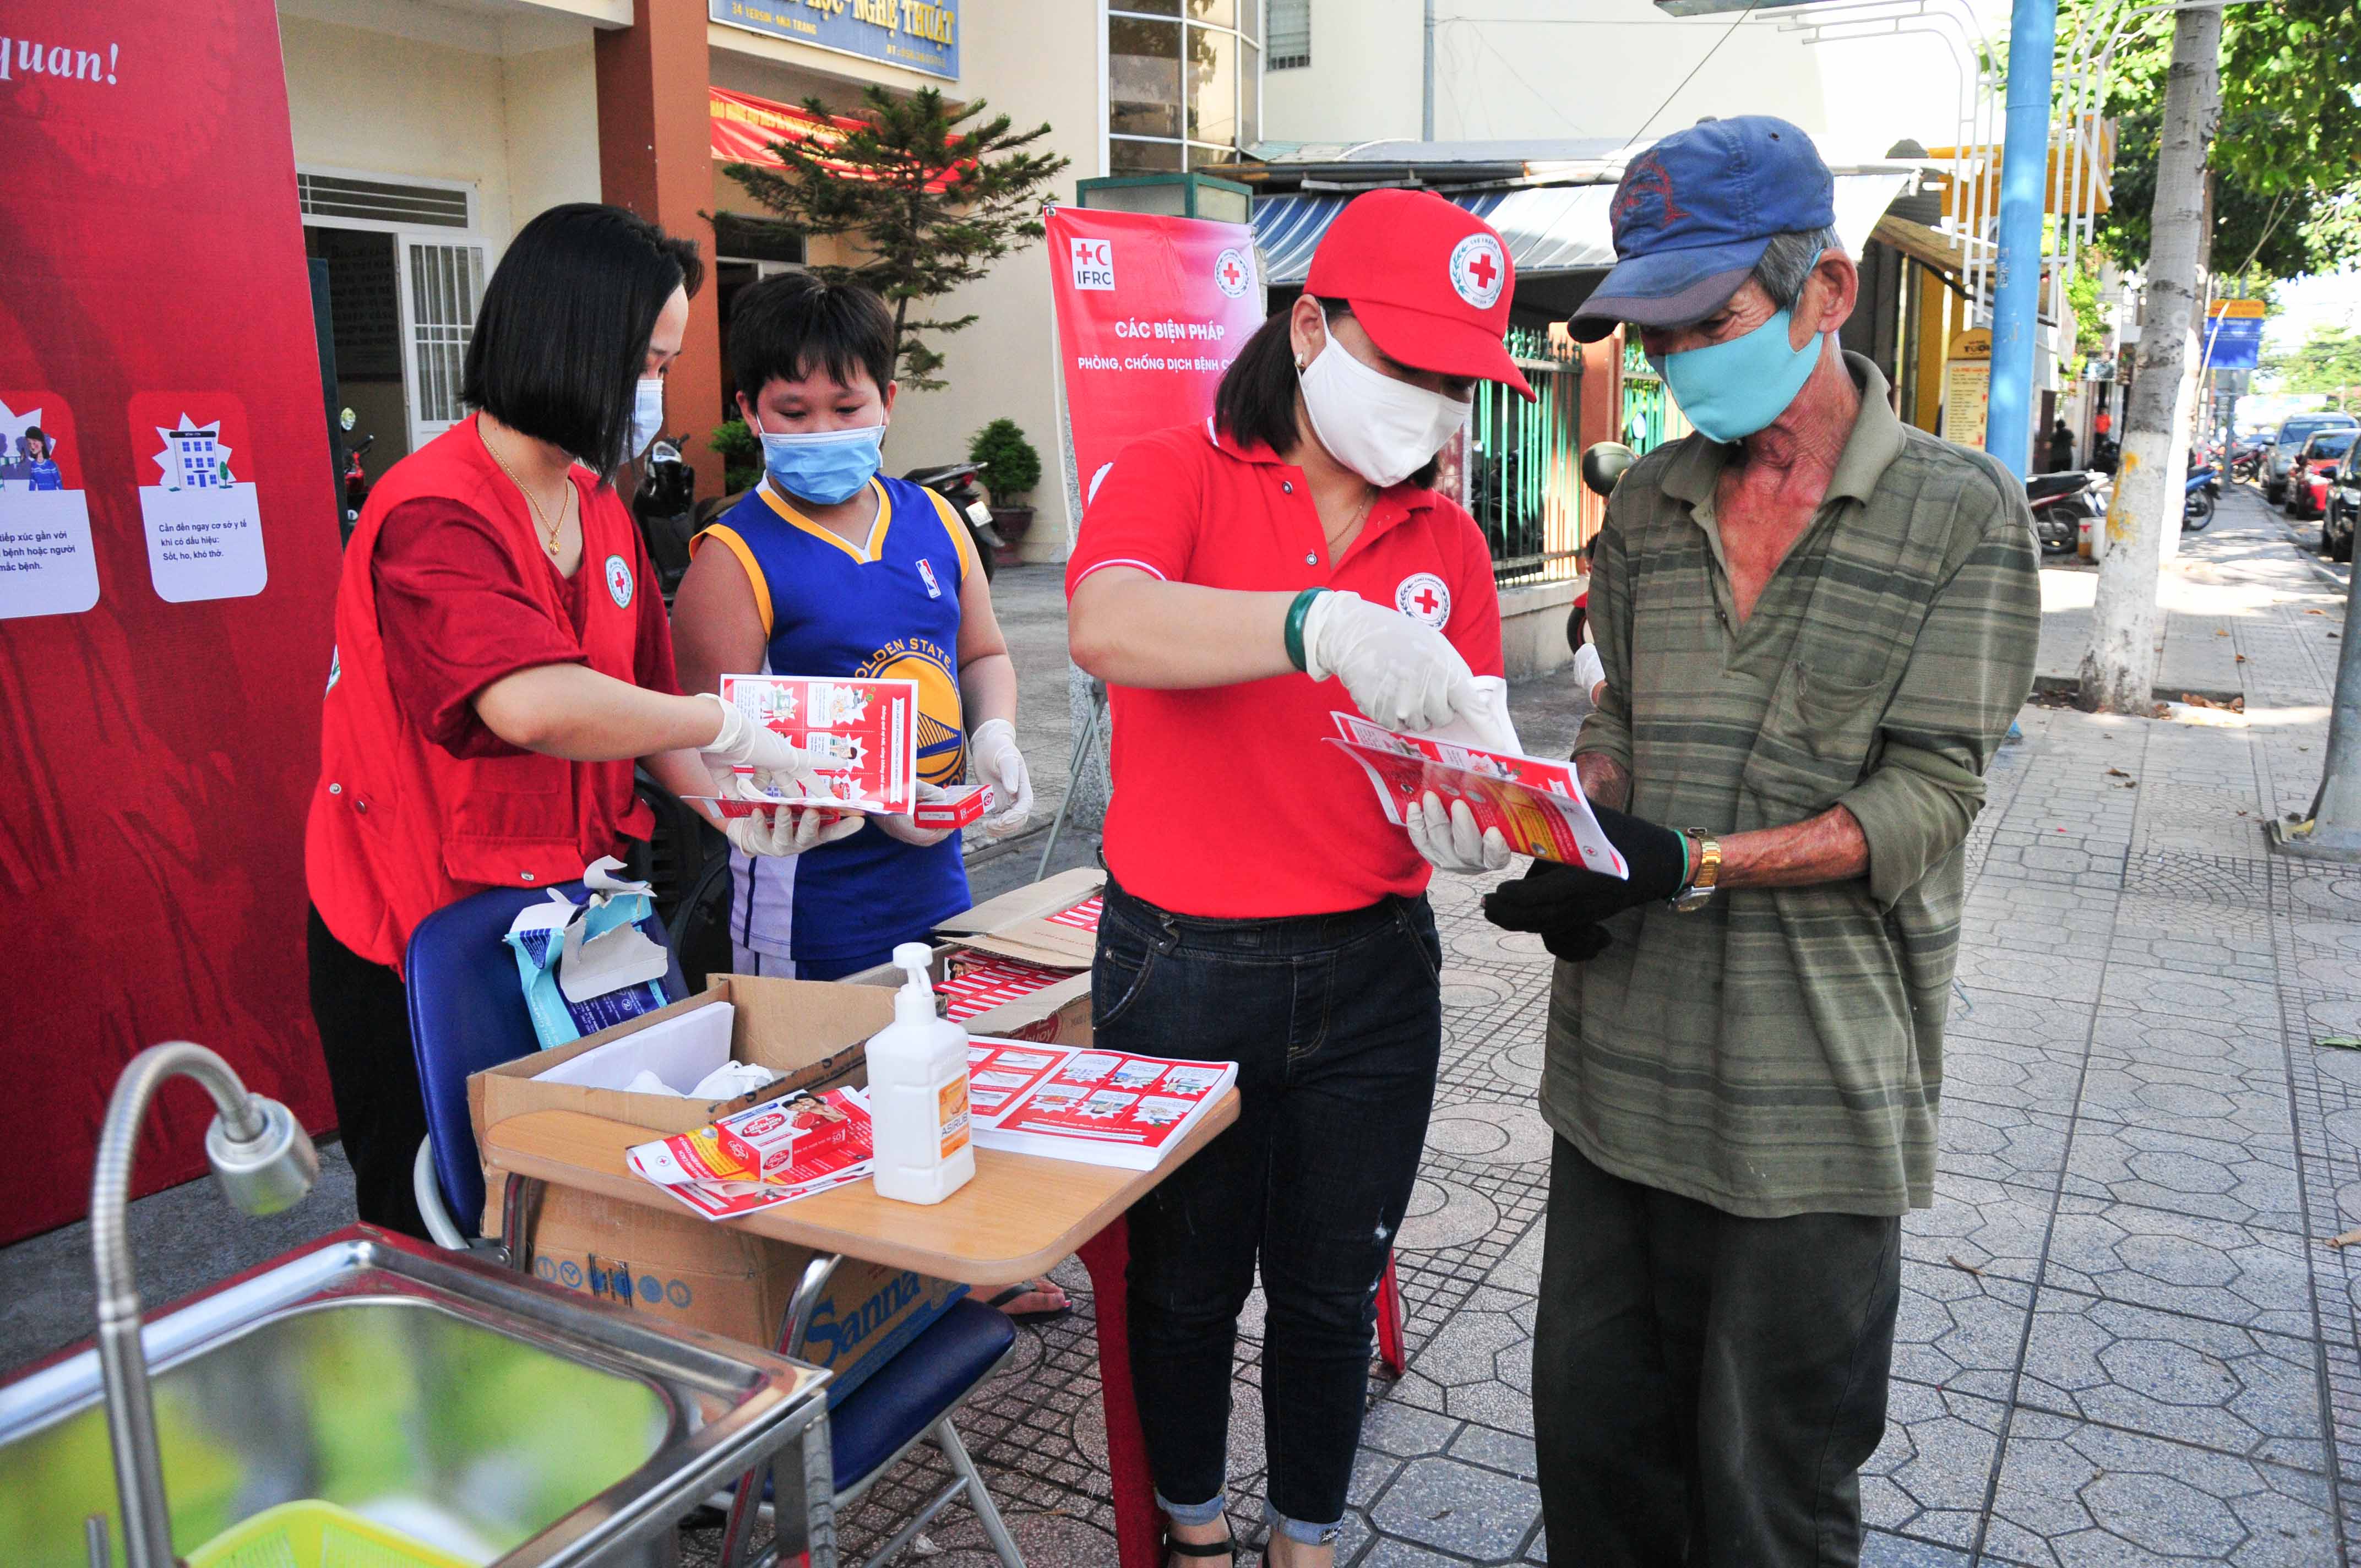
[[0, 0, 338, 1242]]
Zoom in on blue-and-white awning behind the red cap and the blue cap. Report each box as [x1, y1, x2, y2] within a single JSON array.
[[1254, 170, 1910, 286]]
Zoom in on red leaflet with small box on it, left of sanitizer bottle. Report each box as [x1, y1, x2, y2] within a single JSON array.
[[630, 1088, 876, 1218]]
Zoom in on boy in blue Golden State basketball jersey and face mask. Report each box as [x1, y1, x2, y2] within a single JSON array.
[[673, 271, 1032, 980]]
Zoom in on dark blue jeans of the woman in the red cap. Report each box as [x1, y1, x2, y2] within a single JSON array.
[[1091, 881, 1443, 1526]]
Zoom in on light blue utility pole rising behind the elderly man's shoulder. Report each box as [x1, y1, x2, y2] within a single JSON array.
[[1983, 0, 2066, 480]]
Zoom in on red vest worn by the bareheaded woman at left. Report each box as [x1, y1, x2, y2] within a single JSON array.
[[304, 418, 654, 971]]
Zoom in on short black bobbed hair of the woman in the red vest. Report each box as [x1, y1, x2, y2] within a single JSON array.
[[460, 201, 706, 477]]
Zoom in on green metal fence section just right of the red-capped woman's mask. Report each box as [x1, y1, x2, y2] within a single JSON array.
[[1466, 326, 1582, 583]]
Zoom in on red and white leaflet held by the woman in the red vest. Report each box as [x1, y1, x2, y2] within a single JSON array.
[[722, 676, 918, 815]]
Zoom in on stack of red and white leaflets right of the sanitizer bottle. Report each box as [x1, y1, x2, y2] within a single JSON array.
[[968, 1037, 1237, 1171]]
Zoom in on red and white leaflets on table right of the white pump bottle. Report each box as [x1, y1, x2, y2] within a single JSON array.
[[975, 1051, 1237, 1171]]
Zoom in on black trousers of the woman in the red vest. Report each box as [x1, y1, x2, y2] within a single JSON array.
[[304, 909, 432, 1238]]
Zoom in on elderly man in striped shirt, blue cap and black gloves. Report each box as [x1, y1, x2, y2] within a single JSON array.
[[1485, 116, 2040, 1568]]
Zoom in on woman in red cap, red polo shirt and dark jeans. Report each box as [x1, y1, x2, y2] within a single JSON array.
[[1067, 191, 1532, 1568]]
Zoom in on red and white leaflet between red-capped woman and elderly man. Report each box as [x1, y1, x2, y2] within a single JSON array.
[[1329, 713, 1631, 879]]
